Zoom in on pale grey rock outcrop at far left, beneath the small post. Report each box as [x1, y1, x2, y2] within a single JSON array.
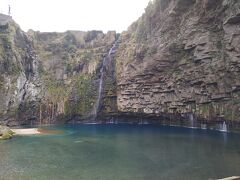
[[0, 14, 41, 124]]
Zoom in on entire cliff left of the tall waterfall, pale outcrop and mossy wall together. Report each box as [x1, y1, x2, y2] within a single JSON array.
[[0, 14, 117, 125]]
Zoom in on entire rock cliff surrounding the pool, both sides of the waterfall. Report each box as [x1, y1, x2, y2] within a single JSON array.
[[0, 0, 240, 126]]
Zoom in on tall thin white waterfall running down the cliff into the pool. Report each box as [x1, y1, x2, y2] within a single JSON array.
[[92, 43, 116, 120]]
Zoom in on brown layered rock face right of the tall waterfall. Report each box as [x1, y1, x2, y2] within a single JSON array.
[[116, 0, 240, 121]]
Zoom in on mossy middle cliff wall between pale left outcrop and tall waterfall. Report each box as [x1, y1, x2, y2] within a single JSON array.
[[28, 31, 117, 123]]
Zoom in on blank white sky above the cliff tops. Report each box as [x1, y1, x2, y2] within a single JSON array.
[[0, 0, 149, 32]]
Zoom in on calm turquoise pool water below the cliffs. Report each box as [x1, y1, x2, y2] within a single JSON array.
[[0, 125, 240, 180]]
